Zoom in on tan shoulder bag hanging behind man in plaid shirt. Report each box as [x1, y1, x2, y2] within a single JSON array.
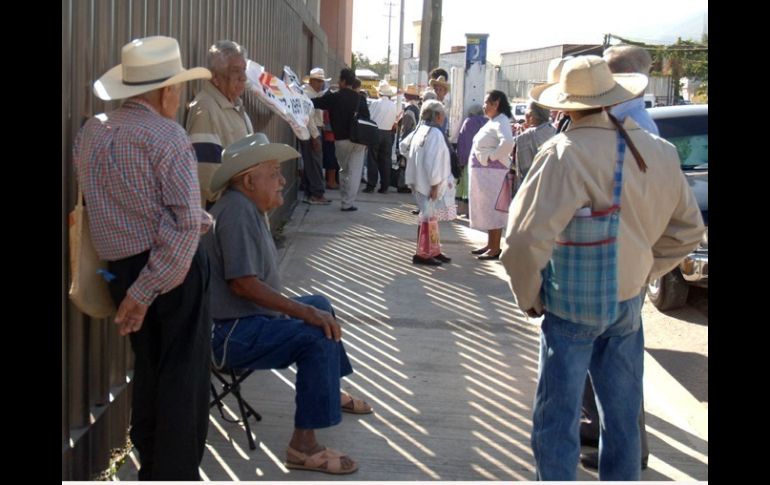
[[69, 188, 116, 318]]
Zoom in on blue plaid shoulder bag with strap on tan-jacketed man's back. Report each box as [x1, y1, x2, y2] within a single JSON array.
[[540, 133, 626, 326]]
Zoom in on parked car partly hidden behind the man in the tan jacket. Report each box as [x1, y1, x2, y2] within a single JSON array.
[[647, 104, 709, 310]]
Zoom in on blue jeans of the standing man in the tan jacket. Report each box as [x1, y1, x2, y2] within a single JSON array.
[[532, 293, 644, 480]]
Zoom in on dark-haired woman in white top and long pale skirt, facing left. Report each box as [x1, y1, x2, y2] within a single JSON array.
[[468, 90, 513, 260]]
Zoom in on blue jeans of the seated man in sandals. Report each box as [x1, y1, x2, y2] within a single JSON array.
[[212, 295, 353, 429]]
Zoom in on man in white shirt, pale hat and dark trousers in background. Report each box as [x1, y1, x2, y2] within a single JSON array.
[[364, 80, 398, 194]]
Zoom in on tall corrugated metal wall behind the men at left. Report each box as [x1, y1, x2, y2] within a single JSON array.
[[61, 0, 330, 480]]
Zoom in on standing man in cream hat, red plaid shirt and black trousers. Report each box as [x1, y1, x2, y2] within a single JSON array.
[[73, 37, 211, 480]]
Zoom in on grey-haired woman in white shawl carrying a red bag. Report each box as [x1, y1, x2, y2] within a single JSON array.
[[399, 100, 457, 266]]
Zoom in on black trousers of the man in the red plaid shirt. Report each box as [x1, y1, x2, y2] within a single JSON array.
[[109, 247, 211, 480]]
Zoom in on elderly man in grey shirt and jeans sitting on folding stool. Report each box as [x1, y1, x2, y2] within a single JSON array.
[[203, 133, 372, 474]]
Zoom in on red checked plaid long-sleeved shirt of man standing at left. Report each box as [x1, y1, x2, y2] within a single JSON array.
[[73, 98, 211, 305]]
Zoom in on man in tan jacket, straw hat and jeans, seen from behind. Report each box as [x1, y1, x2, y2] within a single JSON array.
[[501, 56, 704, 480]]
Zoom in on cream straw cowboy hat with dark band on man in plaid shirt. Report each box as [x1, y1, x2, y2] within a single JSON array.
[[94, 36, 211, 101]]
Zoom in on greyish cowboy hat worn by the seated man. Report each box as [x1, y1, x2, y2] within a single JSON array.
[[209, 133, 300, 193]]
